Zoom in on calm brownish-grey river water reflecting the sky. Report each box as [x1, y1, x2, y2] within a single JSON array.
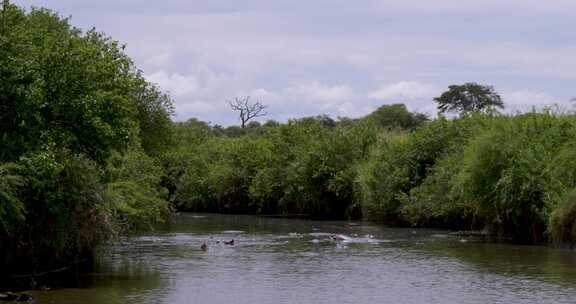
[[33, 213, 576, 304]]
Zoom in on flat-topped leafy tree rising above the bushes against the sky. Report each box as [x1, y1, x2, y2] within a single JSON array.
[[434, 82, 504, 114]]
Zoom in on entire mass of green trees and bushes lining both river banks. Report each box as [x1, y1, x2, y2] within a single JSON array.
[[0, 1, 576, 285]]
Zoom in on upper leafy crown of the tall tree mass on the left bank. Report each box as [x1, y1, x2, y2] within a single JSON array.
[[0, 6, 171, 164]]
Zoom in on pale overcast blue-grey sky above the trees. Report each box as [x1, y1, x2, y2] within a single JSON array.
[[12, 0, 576, 125]]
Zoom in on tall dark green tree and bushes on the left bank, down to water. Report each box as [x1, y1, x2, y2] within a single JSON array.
[[0, 5, 172, 276]]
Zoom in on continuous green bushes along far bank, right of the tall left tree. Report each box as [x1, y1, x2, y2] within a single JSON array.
[[162, 104, 576, 243]]
